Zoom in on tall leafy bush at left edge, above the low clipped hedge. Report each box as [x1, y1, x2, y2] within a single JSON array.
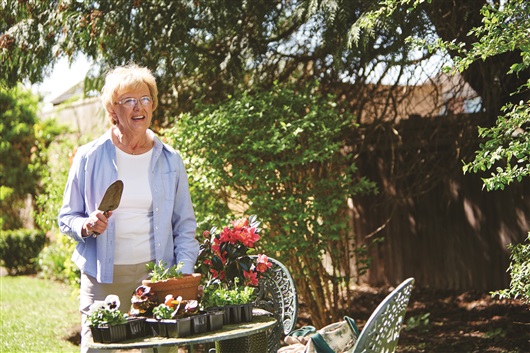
[[0, 86, 67, 230]]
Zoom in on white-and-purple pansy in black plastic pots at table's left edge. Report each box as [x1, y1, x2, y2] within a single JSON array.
[[87, 294, 146, 343]]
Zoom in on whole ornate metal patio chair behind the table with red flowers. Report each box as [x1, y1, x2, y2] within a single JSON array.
[[210, 257, 298, 353]]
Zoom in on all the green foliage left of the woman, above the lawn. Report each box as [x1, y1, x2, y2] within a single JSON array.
[[0, 86, 81, 288]]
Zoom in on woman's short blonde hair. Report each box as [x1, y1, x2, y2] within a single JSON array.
[[101, 64, 158, 125]]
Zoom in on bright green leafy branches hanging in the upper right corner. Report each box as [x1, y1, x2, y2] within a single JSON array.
[[338, 0, 530, 190]]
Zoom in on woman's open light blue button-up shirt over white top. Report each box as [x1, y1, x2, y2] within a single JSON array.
[[58, 130, 199, 283]]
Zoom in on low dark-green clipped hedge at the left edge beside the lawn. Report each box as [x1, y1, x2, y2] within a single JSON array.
[[0, 229, 48, 275]]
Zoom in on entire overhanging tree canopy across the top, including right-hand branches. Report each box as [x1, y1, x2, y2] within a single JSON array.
[[0, 0, 530, 189]]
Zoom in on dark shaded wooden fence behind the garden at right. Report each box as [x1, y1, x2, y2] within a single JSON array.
[[352, 116, 530, 290]]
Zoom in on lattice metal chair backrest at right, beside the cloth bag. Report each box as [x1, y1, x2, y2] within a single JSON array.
[[351, 278, 414, 353]]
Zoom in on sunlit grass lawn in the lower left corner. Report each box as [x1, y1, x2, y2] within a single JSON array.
[[0, 276, 81, 353]]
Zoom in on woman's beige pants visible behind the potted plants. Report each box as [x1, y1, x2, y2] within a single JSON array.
[[79, 262, 177, 353]]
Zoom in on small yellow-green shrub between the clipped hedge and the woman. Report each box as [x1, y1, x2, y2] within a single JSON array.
[[39, 234, 80, 288]]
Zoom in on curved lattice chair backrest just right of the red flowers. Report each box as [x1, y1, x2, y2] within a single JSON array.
[[250, 257, 298, 353]]
